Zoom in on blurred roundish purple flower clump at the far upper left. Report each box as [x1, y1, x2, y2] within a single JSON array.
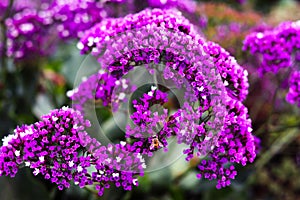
[[5, 9, 53, 60]]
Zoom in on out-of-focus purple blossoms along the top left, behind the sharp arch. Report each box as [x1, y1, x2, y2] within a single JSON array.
[[0, 0, 195, 60]]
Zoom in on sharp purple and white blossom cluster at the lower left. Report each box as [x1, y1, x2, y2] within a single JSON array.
[[0, 107, 145, 195]]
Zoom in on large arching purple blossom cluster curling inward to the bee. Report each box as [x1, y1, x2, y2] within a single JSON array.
[[71, 9, 256, 188]]
